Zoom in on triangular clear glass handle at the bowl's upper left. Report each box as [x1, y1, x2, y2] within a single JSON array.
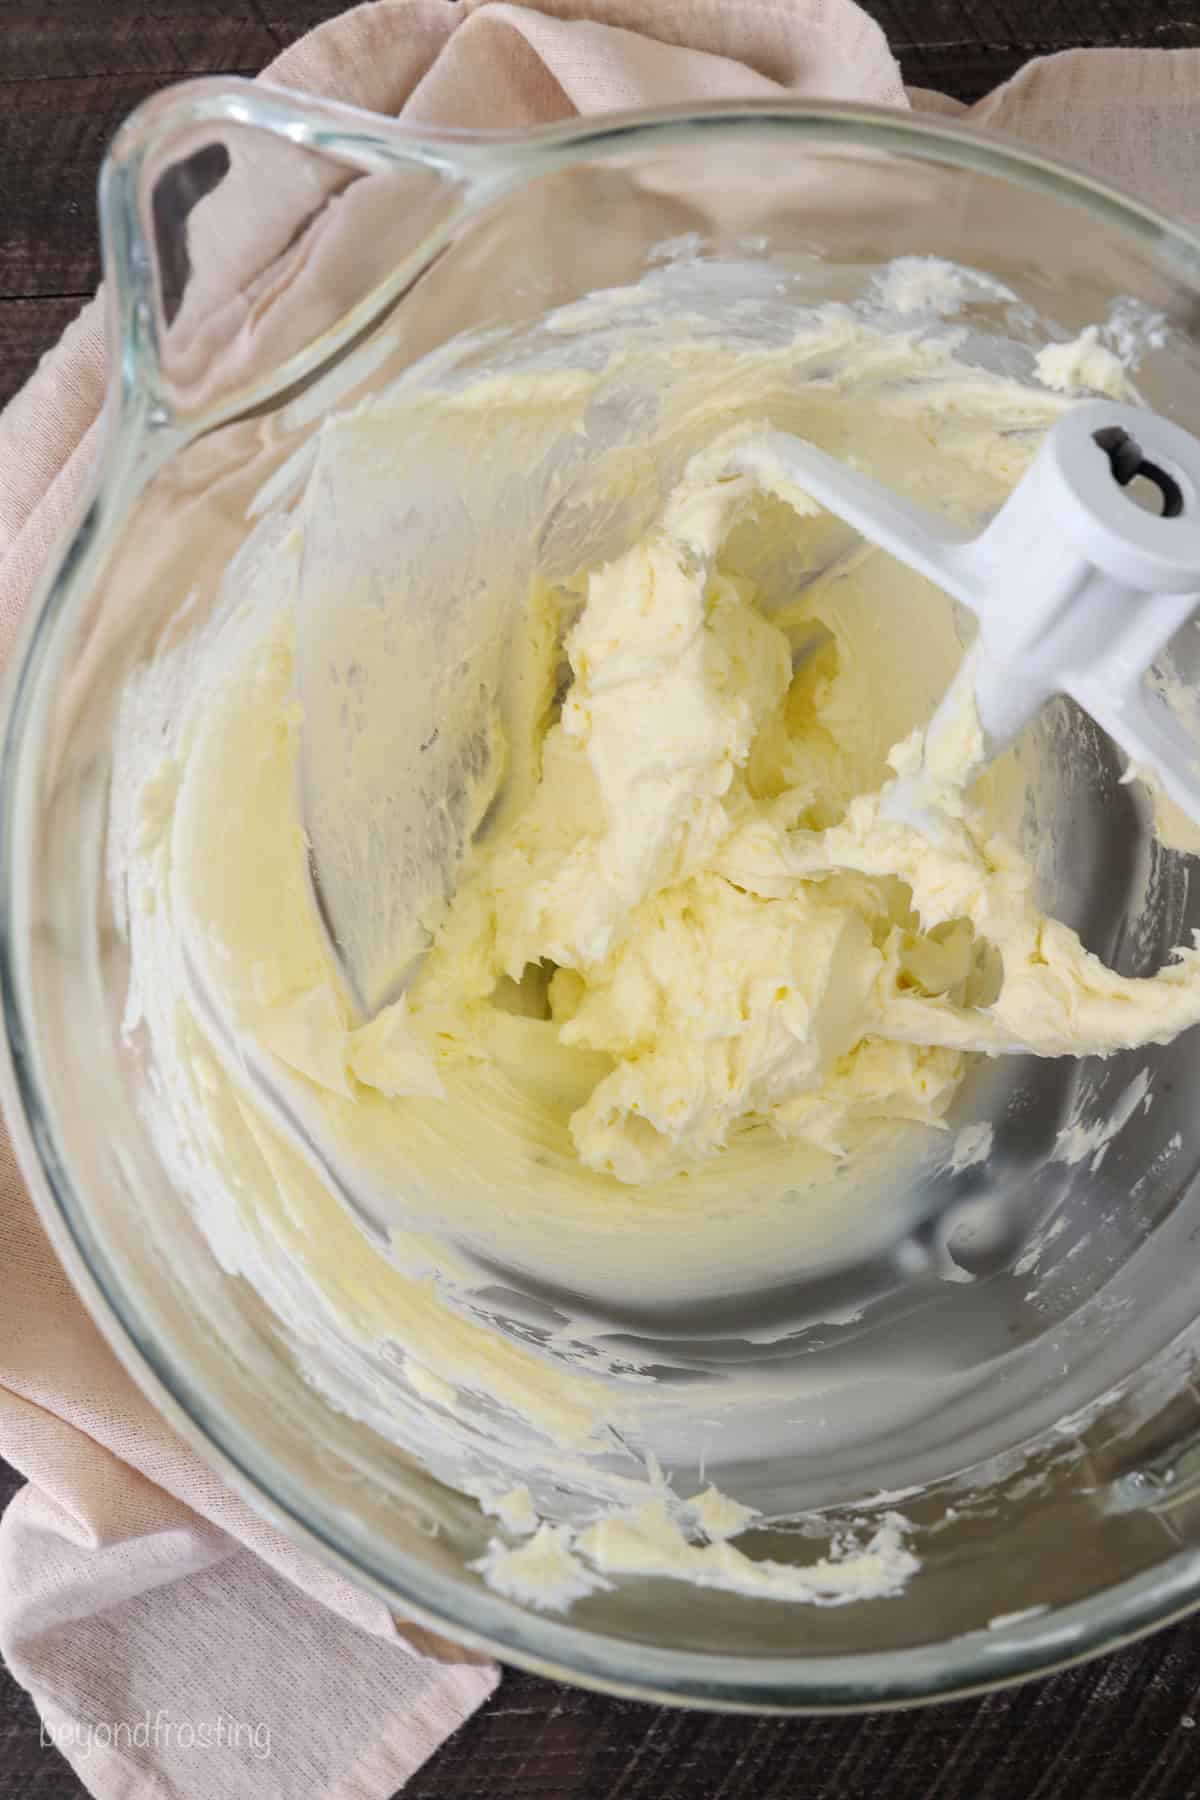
[[99, 79, 492, 436]]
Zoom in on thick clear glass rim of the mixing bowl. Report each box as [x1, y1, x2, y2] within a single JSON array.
[[0, 79, 1200, 1712]]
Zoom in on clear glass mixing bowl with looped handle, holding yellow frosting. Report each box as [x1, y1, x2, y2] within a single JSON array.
[[0, 83, 1200, 1710]]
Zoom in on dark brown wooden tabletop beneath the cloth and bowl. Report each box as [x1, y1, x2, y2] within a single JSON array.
[[9, 0, 1200, 1800]]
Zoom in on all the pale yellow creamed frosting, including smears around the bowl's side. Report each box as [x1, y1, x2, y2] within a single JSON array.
[[117, 280, 1200, 1607]]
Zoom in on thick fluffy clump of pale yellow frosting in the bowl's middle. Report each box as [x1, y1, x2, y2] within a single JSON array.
[[401, 430, 1200, 1183]]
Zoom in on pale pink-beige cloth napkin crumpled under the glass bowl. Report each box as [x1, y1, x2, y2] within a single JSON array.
[[0, 0, 1200, 1800]]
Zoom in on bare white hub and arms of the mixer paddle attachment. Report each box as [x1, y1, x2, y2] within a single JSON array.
[[729, 400, 1200, 826]]
